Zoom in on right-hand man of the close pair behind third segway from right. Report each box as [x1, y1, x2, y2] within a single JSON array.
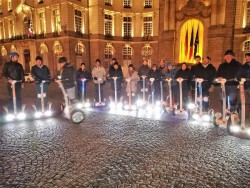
[[192, 56, 216, 111]]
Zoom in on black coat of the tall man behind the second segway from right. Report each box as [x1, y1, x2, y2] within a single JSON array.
[[217, 59, 241, 85]]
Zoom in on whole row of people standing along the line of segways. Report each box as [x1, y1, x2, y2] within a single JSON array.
[[3, 50, 250, 114]]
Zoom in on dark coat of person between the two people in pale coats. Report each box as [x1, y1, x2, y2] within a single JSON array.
[[109, 67, 123, 91]]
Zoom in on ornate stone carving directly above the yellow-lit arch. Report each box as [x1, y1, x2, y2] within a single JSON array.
[[176, 0, 211, 21]]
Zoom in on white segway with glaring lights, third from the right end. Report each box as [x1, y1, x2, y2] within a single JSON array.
[[188, 78, 214, 122]]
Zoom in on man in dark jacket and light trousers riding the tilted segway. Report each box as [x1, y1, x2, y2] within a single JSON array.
[[58, 57, 76, 102]]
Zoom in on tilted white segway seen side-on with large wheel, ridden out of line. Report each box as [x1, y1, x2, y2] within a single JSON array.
[[56, 80, 85, 124]]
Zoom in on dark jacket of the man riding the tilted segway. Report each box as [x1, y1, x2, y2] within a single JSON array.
[[61, 63, 75, 89]]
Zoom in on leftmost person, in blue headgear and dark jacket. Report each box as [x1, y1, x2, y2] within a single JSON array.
[[3, 52, 24, 112]]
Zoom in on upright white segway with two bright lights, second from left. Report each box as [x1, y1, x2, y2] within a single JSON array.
[[32, 80, 52, 118]]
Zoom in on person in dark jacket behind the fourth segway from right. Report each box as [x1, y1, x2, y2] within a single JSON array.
[[175, 63, 191, 107]]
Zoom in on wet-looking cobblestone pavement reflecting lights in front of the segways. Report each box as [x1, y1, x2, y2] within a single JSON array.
[[0, 112, 250, 188]]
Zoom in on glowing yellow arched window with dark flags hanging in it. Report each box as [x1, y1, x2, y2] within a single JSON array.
[[179, 19, 204, 63]]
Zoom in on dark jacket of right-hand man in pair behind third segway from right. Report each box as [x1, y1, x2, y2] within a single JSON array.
[[192, 63, 216, 92]]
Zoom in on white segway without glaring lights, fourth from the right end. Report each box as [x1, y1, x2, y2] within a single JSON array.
[[173, 78, 188, 119]]
